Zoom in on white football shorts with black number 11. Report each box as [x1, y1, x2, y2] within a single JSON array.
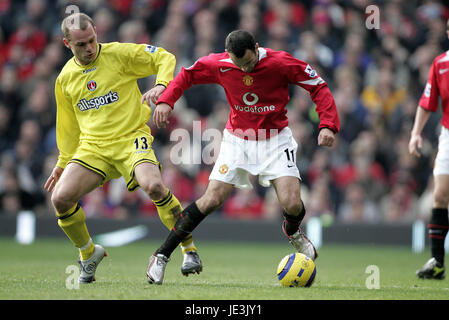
[[209, 127, 301, 189]]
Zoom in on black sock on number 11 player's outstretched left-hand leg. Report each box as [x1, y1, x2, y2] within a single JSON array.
[[156, 202, 206, 258]]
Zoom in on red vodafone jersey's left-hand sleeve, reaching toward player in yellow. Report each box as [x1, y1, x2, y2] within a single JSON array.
[[157, 57, 217, 107]]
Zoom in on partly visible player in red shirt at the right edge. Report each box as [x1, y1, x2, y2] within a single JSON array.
[[409, 20, 449, 279]]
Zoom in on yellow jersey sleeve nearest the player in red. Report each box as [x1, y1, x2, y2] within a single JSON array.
[[120, 43, 176, 87]]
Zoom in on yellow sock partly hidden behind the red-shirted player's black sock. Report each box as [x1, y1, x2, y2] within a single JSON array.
[[153, 190, 197, 254]]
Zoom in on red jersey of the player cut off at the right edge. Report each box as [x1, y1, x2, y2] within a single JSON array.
[[418, 51, 449, 129]]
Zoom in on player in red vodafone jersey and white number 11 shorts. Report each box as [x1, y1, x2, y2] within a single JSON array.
[[147, 30, 340, 284]]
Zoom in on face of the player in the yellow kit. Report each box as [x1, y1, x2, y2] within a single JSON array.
[[64, 24, 97, 65]]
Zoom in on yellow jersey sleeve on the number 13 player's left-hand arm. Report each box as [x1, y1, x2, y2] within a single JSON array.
[[55, 78, 80, 169]]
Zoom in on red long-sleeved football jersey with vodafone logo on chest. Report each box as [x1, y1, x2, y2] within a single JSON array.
[[158, 48, 340, 139]]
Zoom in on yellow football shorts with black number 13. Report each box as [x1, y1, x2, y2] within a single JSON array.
[[69, 127, 161, 191]]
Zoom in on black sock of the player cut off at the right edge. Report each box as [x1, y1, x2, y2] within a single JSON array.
[[428, 208, 449, 265]]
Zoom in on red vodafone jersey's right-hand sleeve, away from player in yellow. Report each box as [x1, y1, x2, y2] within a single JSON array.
[[281, 52, 340, 133]]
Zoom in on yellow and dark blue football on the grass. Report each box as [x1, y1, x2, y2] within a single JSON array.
[[276, 252, 316, 287]]
